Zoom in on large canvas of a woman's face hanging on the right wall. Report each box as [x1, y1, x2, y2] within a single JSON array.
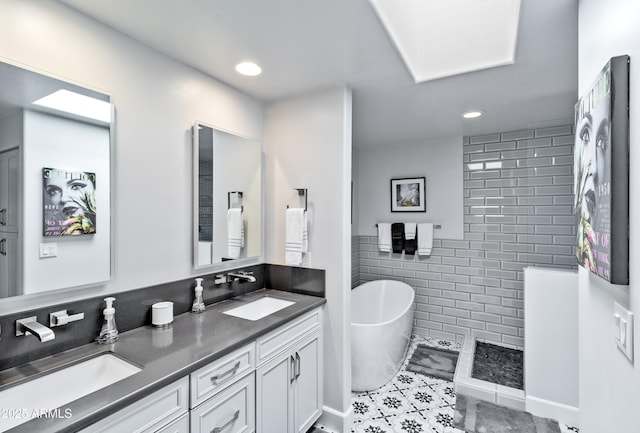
[[573, 56, 629, 284]]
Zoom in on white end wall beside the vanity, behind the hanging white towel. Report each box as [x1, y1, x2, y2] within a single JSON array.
[[265, 88, 351, 432]]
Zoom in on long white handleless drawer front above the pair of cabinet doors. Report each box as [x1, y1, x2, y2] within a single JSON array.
[[256, 307, 322, 365]]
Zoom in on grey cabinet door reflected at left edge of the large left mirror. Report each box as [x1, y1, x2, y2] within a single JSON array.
[[0, 150, 20, 232]]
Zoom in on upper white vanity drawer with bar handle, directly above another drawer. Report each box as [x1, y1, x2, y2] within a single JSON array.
[[191, 342, 256, 409]]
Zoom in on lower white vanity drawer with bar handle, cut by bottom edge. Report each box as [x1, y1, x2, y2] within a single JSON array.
[[191, 372, 256, 433]]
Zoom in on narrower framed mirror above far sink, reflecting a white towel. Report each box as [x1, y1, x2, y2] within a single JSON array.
[[193, 122, 263, 269]]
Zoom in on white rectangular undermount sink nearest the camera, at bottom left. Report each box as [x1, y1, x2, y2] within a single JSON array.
[[0, 353, 142, 431]]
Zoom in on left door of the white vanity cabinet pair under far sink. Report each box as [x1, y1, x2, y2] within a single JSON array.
[[256, 352, 294, 433]]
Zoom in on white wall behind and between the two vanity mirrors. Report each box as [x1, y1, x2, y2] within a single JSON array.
[[0, 0, 263, 305]]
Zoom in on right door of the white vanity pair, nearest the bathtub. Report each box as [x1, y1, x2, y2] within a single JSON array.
[[293, 331, 323, 433]]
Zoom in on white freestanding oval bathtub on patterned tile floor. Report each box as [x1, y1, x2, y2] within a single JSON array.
[[351, 280, 415, 392]]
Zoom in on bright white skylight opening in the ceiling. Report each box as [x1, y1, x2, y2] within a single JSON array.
[[369, 0, 521, 83]]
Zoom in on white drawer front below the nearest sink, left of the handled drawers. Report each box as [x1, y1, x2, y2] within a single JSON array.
[[81, 377, 189, 433]]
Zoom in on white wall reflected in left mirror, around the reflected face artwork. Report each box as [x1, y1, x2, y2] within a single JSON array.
[[21, 110, 111, 294]]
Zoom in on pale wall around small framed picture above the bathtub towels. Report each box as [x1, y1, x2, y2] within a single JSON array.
[[354, 137, 463, 239]]
